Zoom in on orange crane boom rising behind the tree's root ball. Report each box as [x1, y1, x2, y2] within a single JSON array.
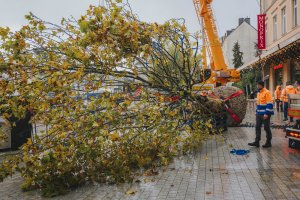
[[193, 0, 240, 86]]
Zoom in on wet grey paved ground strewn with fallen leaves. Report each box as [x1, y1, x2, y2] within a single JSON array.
[[0, 111, 300, 200]]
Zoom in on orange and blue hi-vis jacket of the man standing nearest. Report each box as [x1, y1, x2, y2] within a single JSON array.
[[256, 88, 274, 115]]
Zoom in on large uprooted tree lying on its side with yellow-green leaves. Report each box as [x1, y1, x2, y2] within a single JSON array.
[[0, 0, 222, 196]]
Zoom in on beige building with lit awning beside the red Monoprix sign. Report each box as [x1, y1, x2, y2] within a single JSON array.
[[239, 0, 300, 94]]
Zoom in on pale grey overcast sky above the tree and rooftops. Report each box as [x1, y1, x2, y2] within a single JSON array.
[[0, 0, 259, 35]]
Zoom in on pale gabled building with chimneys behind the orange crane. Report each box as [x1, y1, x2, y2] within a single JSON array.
[[221, 18, 257, 68]]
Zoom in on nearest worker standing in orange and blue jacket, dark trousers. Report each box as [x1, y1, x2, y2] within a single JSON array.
[[248, 81, 274, 148]]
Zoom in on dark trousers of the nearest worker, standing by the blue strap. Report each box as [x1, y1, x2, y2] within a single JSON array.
[[255, 115, 272, 142]]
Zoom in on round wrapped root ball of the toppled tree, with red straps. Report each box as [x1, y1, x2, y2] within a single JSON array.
[[213, 86, 247, 127]]
